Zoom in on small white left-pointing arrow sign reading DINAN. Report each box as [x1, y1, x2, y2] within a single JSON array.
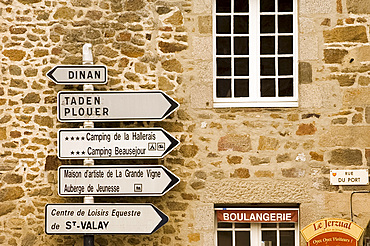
[[46, 65, 108, 84]]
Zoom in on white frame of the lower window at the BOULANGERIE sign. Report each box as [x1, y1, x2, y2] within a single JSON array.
[[214, 208, 300, 246]]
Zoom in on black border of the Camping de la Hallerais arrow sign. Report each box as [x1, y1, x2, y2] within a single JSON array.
[[57, 127, 180, 159]]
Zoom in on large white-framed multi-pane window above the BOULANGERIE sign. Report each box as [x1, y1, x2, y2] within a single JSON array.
[[213, 0, 298, 107]]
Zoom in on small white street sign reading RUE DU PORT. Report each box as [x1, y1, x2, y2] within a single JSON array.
[[330, 169, 369, 185]]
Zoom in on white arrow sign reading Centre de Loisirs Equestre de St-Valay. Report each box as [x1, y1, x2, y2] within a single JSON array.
[[45, 203, 168, 234]]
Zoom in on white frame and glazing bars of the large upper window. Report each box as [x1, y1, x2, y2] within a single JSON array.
[[213, 0, 298, 108]]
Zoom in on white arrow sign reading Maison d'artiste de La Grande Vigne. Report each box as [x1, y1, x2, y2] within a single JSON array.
[[58, 165, 180, 196]]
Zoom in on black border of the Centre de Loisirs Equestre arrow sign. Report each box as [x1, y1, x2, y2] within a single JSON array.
[[44, 203, 168, 235]]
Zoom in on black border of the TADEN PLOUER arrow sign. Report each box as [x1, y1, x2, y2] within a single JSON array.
[[57, 90, 179, 122]]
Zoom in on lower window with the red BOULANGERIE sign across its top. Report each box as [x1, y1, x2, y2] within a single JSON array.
[[216, 208, 299, 246]]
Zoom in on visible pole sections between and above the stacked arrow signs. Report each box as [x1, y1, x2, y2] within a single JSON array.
[[82, 43, 94, 246]]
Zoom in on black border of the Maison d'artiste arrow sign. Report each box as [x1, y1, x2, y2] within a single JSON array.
[[58, 165, 180, 197]]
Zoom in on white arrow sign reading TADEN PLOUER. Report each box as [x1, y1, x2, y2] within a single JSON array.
[[58, 91, 179, 122]]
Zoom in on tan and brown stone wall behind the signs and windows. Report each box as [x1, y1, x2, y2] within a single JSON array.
[[0, 0, 370, 246]]
